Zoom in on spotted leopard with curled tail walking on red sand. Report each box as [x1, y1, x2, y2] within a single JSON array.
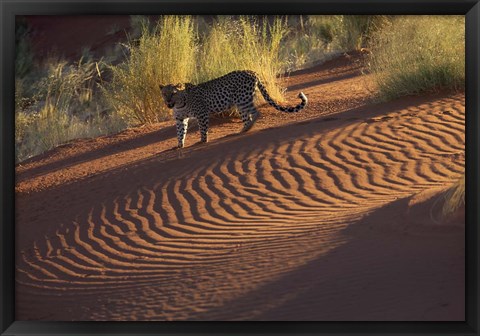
[[159, 70, 308, 148]]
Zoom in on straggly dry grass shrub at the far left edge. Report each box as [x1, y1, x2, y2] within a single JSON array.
[[15, 60, 125, 162]]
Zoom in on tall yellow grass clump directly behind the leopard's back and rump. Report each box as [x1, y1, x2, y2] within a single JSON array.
[[193, 16, 287, 101]]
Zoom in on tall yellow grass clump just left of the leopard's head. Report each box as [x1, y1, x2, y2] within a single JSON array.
[[102, 16, 196, 125]]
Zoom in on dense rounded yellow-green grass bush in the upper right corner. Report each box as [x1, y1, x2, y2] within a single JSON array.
[[369, 16, 465, 100]]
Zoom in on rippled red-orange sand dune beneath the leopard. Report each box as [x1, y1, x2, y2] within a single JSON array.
[[16, 54, 465, 320]]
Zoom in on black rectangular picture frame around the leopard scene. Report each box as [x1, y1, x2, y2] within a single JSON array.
[[0, 0, 480, 336]]
